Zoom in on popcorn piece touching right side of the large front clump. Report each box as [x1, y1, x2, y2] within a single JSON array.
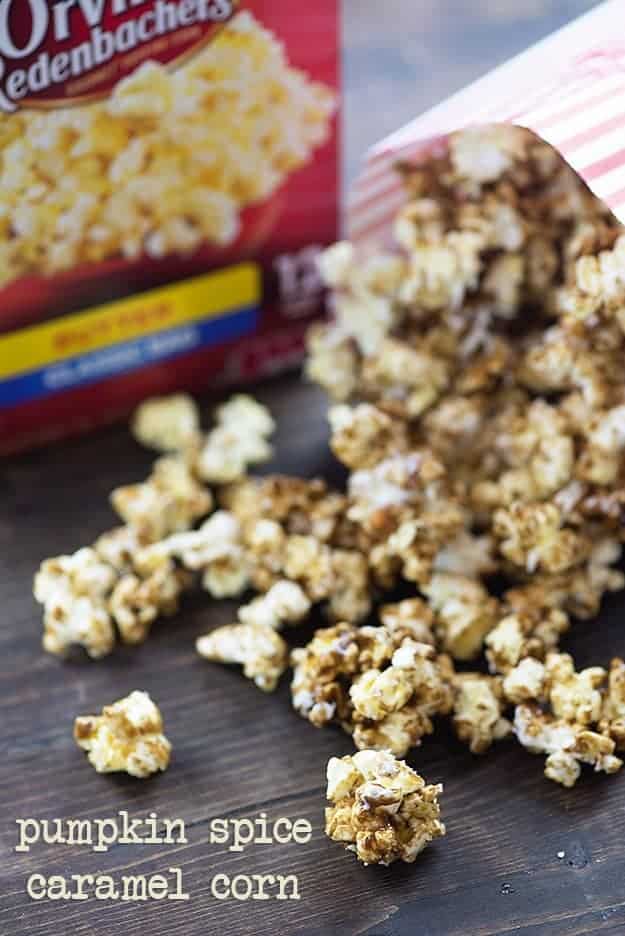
[[453, 673, 512, 754]]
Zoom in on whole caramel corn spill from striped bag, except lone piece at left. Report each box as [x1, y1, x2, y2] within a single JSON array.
[[35, 127, 625, 864]]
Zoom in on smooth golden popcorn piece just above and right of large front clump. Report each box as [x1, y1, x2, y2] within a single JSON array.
[[422, 572, 497, 660]]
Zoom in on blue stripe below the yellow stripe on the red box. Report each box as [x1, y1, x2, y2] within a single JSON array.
[[0, 306, 258, 409]]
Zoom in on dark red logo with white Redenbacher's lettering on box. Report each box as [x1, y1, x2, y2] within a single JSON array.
[[0, 0, 238, 113]]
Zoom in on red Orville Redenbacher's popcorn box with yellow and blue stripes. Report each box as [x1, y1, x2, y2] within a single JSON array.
[[0, 0, 339, 453]]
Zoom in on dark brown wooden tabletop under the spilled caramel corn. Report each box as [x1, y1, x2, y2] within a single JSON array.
[[0, 378, 625, 936]]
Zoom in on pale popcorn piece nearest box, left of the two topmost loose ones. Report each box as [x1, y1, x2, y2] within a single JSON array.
[[131, 393, 200, 452]]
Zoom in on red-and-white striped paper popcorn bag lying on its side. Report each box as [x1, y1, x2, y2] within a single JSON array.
[[347, 0, 625, 248]]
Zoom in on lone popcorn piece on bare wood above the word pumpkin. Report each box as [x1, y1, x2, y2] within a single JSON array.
[[74, 691, 171, 777]]
